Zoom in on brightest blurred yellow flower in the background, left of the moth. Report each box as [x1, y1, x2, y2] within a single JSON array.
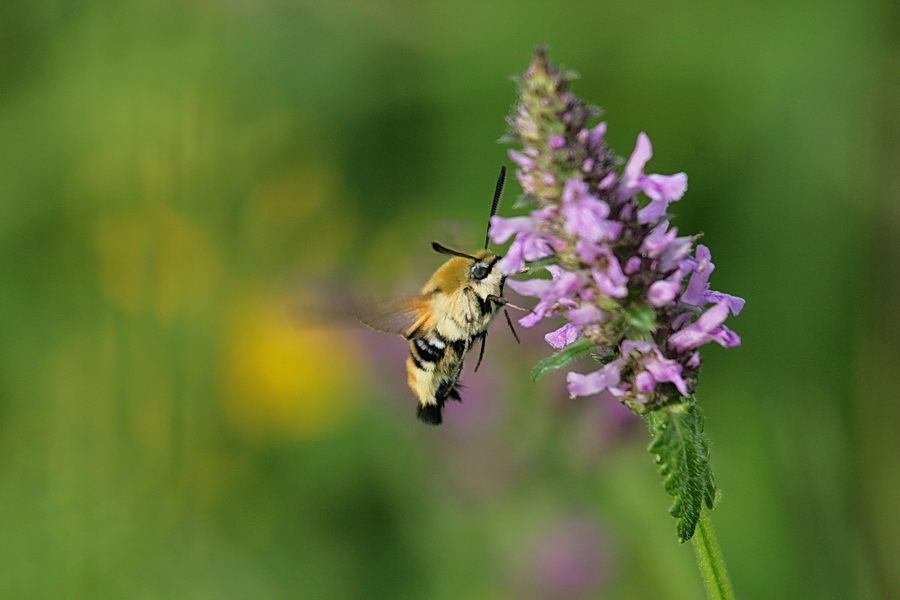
[[225, 292, 365, 437]]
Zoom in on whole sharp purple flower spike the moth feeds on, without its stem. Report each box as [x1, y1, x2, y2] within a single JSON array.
[[490, 48, 744, 412]]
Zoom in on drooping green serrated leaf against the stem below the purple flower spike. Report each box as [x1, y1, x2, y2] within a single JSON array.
[[647, 398, 717, 542]]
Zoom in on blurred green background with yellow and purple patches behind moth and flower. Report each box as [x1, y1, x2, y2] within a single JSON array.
[[0, 0, 900, 600]]
